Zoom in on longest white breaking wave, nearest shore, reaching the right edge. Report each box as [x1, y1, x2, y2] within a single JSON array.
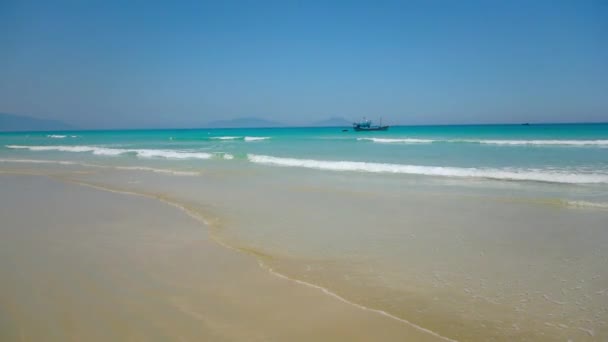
[[247, 154, 608, 184]]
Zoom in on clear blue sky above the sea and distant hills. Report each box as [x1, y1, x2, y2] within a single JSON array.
[[0, 0, 608, 128]]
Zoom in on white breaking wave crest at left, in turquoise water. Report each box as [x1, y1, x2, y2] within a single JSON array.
[[6, 145, 213, 159]]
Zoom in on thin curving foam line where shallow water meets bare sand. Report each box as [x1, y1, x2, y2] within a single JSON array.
[[54, 176, 458, 342]]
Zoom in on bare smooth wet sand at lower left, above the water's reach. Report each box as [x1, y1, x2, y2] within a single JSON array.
[[0, 175, 440, 341]]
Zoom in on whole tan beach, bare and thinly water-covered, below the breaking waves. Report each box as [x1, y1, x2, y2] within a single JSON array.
[[0, 153, 608, 341]]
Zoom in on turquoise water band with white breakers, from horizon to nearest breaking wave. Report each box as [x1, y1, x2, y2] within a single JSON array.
[[0, 124, 608, 184]]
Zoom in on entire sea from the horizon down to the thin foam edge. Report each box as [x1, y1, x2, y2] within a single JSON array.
[[0, 124, 608, 341]]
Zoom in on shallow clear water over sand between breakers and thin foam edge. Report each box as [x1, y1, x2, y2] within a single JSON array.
[[0, 157, 605, 341]]
